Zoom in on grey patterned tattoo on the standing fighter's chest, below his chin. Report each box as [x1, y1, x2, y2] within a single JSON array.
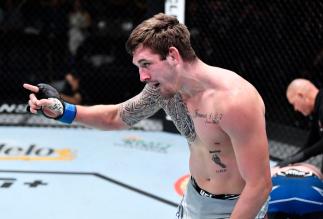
[[161, 94, 196, 142]]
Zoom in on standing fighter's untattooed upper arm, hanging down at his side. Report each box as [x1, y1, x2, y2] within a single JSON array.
[[221, 97, 270, 182]]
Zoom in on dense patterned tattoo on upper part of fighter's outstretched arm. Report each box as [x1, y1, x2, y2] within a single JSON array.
[[120, 85, 160, 126]]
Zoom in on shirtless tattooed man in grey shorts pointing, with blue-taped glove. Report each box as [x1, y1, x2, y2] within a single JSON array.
[[24, 13, 271, 219]]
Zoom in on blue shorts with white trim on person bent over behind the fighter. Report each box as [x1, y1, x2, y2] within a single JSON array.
[[268, 169, 323, 215]]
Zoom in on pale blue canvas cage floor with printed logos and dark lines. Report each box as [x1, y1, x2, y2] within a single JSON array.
[[0, 127, 278, 219]]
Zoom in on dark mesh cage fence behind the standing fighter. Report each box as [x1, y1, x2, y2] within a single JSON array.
[[0, 0, 323, 168]]
